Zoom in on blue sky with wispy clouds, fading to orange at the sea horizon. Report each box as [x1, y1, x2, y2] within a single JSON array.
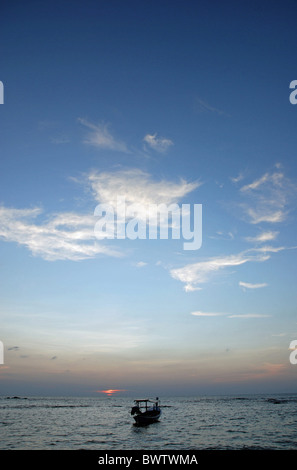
[[0, 0, 297, 398]]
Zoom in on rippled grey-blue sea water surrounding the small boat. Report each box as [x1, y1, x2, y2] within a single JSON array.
[[0, 394, 297, 451]]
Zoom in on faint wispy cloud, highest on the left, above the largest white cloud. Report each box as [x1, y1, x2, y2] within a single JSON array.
[[78, 118, 129, 153]]
